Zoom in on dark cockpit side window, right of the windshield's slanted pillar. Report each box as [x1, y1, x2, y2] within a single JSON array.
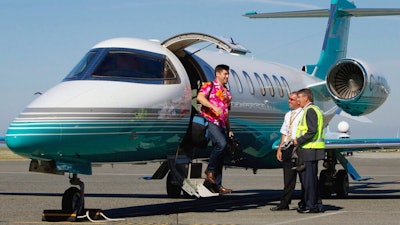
[[92, 50, 179, 84]]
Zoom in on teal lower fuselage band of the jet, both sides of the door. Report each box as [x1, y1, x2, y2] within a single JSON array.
[[7, 107, 283, 168]]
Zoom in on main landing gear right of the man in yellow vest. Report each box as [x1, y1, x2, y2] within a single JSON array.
[[319, 150, 349, 198]]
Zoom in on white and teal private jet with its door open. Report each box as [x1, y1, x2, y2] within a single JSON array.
[[5, 0, 400, 212]]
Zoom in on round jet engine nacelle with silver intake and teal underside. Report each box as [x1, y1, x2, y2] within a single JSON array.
[[326, 59, 390, 116]]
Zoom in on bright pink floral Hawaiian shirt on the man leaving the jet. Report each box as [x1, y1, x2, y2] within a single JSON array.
[[200, 80, 232, 128]]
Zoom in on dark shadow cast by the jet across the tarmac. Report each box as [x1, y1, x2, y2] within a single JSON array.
[[0, 184, 400, 218]]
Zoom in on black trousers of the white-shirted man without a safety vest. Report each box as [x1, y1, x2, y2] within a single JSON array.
[[279, 148, 297, 207]]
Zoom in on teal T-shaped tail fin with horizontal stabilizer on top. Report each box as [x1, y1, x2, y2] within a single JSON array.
[[244, 0, 400, 79]]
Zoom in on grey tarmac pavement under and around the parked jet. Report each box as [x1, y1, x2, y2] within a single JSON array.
[[0, 152, 400, 225]]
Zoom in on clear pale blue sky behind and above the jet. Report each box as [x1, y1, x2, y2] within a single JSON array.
[[0, 0, 400, 137]]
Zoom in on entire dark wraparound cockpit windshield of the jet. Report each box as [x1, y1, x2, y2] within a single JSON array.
[[66, 49, 180, 84]]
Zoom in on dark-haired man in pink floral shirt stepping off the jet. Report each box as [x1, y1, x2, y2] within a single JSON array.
[[197, 65, 233, 194]]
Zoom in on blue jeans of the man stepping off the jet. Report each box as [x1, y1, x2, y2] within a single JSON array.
[[207, 122, 227, 187]]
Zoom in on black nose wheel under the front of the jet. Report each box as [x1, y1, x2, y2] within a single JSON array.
[[61, 187, 85, 214]]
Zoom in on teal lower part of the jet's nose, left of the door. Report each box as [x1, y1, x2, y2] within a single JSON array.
[[6, 119, 187, 162]]
